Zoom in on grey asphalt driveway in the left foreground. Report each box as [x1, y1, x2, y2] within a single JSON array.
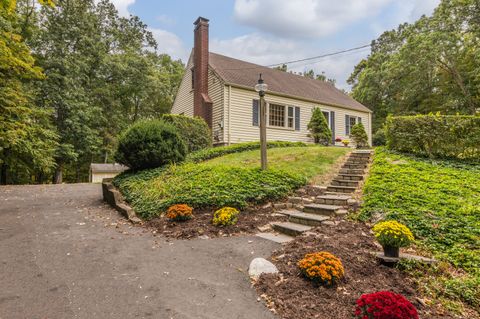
[[0, 184, 278, 319]]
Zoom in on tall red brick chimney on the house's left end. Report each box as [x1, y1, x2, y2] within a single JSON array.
[[193, 17, 212, 128]]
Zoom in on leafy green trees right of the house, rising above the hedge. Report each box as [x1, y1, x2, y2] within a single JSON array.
[[348, 0, 480, 131]]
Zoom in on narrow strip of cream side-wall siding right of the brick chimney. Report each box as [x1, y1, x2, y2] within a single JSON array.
[[208, 69, 225, 144]]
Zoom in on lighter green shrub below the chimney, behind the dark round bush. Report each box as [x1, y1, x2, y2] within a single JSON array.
[[162, 114, 212, 153]]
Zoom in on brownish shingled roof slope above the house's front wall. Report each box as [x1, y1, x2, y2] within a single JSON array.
[[209, 52, 371, 112]]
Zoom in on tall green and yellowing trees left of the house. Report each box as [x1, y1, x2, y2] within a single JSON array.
[[0, 0, 183, 183]]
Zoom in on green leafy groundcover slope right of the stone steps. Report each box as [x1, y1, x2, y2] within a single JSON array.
[[359, 148, 480, 310]]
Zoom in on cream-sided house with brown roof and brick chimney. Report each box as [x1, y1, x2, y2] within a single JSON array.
[[172, 17, 372, 145]]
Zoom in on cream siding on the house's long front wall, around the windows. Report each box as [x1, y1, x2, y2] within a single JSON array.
[[224, 86, 371, 147]]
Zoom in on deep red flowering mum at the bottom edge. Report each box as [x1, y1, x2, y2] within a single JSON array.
[[355, 291, 418, 319]]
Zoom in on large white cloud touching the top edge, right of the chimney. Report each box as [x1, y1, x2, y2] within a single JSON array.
[[234, 0, 394, 37]]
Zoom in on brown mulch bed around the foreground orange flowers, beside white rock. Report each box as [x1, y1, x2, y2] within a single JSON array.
[[255, 221, 454, 319]]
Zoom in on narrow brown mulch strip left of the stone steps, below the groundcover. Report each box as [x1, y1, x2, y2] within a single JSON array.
[[145, 206, 287, 239]]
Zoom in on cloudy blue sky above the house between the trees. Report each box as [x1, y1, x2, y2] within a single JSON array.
[[111, 0, 440, 90]]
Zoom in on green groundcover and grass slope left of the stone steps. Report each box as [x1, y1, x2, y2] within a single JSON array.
[[114, 146, 347, 219]]
